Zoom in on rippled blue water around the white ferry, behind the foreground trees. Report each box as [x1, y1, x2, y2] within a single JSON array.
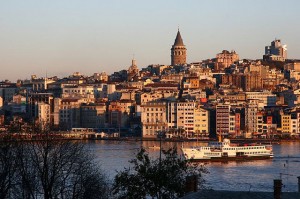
[[87, 140, 300, 192]]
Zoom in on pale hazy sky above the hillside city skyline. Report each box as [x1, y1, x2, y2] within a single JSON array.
[[0, 0, 300, 81]]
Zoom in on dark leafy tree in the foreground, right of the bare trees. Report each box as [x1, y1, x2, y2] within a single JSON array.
[[113, 148, 207, 199]]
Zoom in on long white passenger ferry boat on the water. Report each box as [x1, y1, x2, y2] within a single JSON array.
[[181, 139, 274, 161]]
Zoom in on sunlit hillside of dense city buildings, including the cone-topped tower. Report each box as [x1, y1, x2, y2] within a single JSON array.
[[0, 30, 300, 138]]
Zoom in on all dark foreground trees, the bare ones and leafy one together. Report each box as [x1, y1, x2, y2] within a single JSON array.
[[0, 133, 207, 199]]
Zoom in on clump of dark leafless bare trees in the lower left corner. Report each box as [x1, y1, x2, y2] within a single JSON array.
[[0, 133, 110, 199]]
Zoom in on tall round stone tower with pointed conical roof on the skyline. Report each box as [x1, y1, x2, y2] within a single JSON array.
[[171, 29, 186, 66]]
